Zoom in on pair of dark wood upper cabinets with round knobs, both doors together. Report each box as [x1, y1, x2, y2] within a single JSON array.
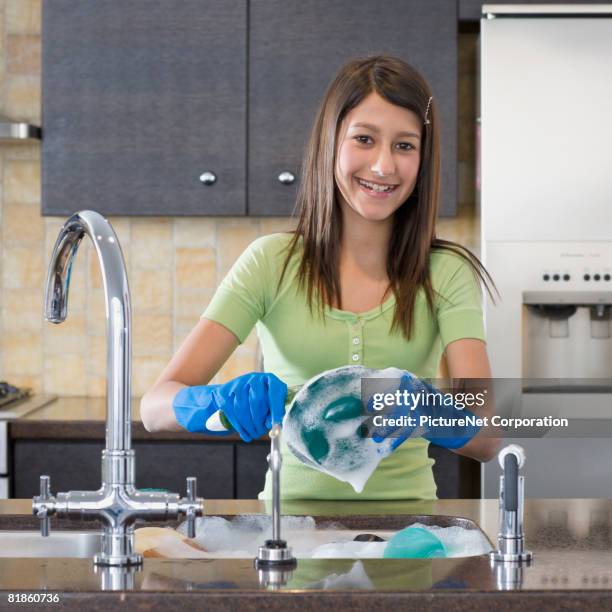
[[42, 0, 457, 216]]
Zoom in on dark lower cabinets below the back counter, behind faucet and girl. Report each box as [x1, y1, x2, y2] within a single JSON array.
[[9, 432, 480, 499]]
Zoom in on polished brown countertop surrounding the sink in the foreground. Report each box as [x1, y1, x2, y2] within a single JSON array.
[[0, 498, 612, 610]]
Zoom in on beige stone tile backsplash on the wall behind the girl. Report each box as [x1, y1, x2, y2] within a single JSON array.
[[0, 0, 479, 397]]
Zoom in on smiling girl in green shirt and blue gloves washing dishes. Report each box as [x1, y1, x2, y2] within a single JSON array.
[[141, 56, 496, 499]]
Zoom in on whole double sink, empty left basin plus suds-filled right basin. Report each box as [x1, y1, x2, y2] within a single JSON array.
[[0, 515, 492, 559]]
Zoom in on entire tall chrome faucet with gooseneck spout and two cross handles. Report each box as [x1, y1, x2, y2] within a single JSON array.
[[32, 210, 203, 566]]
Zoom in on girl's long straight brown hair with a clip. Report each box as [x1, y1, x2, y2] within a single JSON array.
[[279, 56, 495, 340]]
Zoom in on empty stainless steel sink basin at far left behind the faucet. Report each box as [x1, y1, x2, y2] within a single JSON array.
[[0, 530, 102, 559]]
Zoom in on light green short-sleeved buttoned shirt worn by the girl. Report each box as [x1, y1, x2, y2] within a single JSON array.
[[202, 234, 485, 499]]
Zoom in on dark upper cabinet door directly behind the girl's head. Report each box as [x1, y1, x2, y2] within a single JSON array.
[[248, 0, 457, 215]]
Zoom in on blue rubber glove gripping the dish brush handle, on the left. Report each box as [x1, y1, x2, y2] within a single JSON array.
[[172, 372, 287, 442]]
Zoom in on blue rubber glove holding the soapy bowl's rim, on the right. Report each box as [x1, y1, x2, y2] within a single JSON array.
[[368, 373, 481, 450]]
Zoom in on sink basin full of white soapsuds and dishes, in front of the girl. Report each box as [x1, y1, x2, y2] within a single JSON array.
[[136, 514, 492, 559]]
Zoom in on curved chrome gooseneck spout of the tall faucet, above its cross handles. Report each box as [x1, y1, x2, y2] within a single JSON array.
[[45, 210, 132, 451]]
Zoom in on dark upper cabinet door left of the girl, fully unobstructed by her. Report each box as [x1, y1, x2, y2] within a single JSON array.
[[42, 0, 247, 215]]
